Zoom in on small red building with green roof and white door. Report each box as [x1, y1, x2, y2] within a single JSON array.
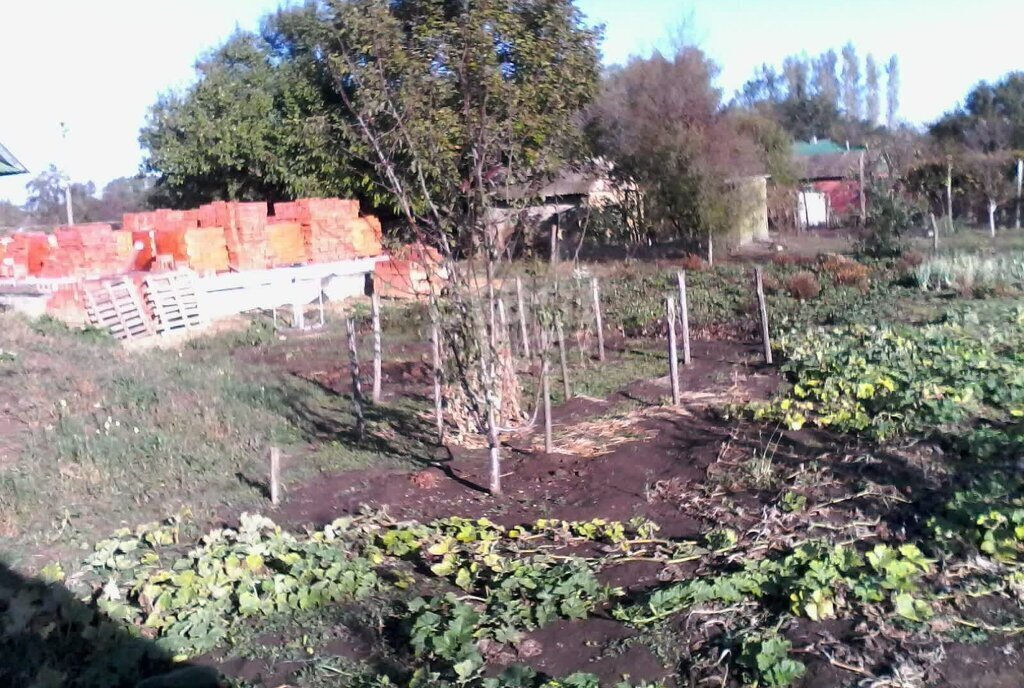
[[793, 139, 867, 228]]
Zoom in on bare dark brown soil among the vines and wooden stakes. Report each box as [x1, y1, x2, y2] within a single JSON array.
[[209, 331, 1024, 688]]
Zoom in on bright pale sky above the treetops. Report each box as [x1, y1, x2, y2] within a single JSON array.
[[0, 0, 1024, 203]]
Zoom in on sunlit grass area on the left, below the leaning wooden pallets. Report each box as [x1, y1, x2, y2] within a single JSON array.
[[0, 314, 424, 552]]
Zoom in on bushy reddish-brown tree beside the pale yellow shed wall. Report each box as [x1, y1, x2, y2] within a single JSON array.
[[591, 46, 765, 244]]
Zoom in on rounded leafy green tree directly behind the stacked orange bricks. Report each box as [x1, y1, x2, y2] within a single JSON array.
[[139, 5, 356, 207]]
